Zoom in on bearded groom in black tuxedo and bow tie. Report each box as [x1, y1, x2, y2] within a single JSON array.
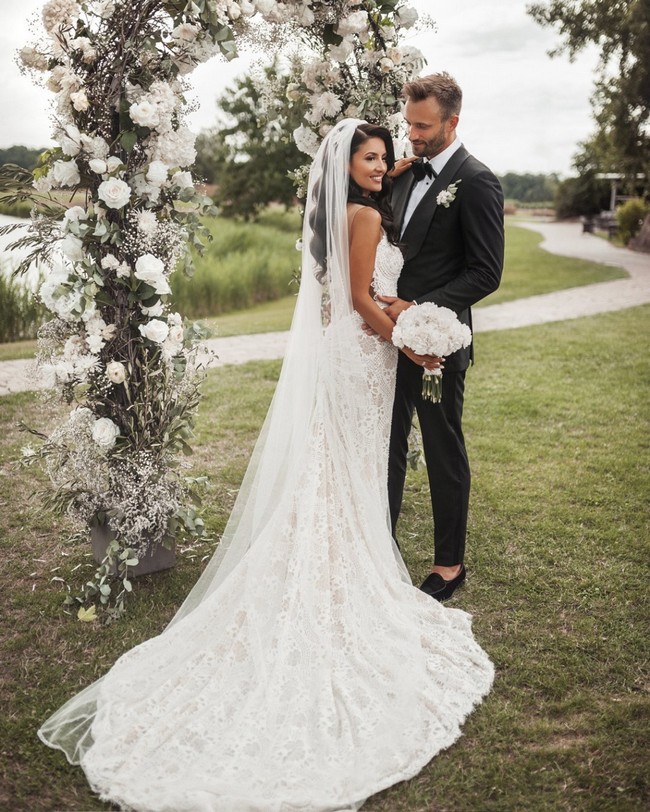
[[385, 73, 504, 600]]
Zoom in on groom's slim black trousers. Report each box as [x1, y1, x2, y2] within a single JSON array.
[[388, 353, 470, 566]]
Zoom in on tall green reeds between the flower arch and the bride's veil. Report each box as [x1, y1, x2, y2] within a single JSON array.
[[170, 209, 300, 318]]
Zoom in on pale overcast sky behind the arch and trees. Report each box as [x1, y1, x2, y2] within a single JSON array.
[[0, 0, 597, 177]]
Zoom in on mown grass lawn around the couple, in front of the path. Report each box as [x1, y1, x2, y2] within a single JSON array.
[[0, 307, 650, 812]]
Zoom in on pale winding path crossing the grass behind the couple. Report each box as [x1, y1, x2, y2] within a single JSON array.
[[0, 223, 650, 396]]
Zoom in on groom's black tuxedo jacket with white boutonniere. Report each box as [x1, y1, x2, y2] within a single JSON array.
[[392, 147, 504, 371]]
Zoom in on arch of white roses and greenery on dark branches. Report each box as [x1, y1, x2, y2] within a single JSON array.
[[7, 0, 424, 614]]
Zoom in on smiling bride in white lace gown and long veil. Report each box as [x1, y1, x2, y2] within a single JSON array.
[[39, 119, 493, 812]]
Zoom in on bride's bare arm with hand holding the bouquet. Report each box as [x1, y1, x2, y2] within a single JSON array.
[[350, 206, 441, 369]]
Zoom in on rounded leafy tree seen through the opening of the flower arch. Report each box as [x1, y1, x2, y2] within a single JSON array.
[[196, 62, 304, 220]]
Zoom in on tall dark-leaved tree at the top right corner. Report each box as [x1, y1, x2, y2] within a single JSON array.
[[528, 0, 650, 193]]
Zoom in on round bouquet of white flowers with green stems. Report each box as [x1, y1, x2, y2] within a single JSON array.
[[392, 302, 472, 403]]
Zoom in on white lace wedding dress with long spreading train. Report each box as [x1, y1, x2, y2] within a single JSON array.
[[39, 120, 493, 812]]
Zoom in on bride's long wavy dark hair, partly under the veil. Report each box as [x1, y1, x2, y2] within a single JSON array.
[[309, 122, 399, 282]]
